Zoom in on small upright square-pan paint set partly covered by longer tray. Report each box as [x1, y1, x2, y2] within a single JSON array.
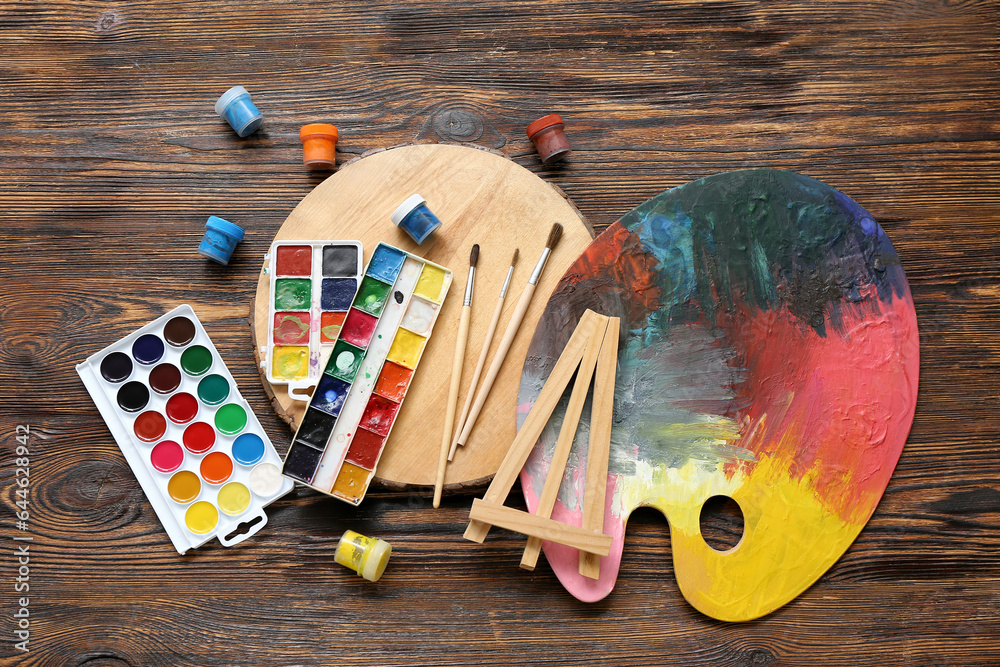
[[265, 241, 364, 401]]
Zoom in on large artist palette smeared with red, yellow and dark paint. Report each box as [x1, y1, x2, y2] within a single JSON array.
[[519, 169, 919, 621]]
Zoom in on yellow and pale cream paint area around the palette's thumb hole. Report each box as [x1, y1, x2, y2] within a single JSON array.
[[613, 456, 865, 622]]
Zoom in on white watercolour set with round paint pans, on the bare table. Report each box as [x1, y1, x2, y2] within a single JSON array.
[[76, 306, 293, 554]]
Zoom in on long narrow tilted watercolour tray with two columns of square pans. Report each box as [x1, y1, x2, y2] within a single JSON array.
[[282, 243, 452, 505]]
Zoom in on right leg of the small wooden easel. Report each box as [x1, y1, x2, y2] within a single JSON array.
[[579, 317, 621, 579]]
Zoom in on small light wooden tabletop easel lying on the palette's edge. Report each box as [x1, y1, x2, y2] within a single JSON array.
[[465, 310, 620, 579]]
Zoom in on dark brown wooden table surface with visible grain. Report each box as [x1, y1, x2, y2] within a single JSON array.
[[0, 0, 1000, 667]]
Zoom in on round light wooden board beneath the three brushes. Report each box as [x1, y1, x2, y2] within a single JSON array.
[[251, 144, 593, 490]]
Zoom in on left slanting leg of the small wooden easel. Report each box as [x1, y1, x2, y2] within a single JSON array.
[[465, 310, 599, 542]]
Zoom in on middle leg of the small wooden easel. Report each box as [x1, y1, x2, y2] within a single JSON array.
[[521, 315, 608, 570]]
